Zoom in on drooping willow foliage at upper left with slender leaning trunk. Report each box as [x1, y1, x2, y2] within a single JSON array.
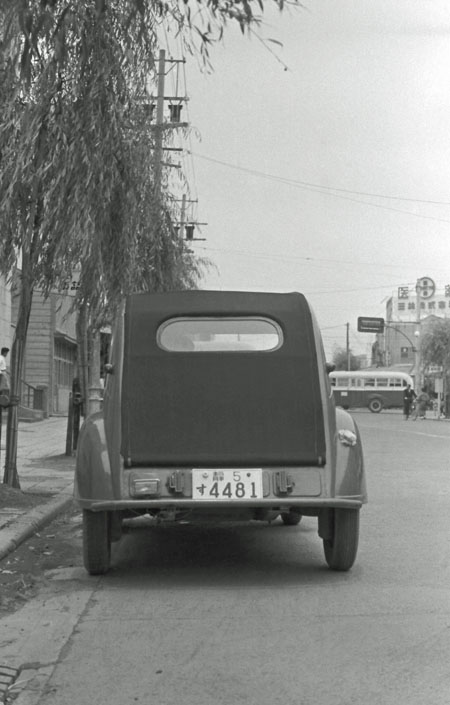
[[0, 0, 292, 487]]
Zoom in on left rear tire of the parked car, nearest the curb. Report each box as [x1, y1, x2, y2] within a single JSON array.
[[83, 509, 111, 575]]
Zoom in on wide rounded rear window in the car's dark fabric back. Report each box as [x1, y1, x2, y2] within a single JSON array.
[[157, 316, 283, 353]]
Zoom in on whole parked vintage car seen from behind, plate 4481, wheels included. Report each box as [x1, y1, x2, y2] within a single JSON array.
[[75, 290, 367, 575]]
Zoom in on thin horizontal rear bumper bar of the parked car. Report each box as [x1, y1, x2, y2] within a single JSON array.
[[77, 496, 365, 514]]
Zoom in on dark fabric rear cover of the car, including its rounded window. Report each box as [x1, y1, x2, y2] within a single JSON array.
[[122, 291, 325, 467]]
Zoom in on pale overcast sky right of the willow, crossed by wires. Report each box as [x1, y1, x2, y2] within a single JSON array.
[[163, 0, 450, 358]]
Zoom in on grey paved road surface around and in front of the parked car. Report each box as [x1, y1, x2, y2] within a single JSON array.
[[0, 411, 450, 705]]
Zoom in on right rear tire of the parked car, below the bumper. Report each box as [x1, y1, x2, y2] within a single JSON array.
[[323, 509, 359, 570]]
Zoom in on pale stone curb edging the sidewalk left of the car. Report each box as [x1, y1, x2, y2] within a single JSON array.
[[0, 495, 73, 561]]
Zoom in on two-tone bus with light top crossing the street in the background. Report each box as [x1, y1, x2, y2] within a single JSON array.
[[330, 370, 413, 414]]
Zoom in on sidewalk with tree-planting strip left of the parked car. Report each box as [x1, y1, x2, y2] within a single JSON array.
[[0, 416, 75, 560]]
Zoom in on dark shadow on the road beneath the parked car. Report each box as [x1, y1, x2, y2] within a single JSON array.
[[107, 518, 359, 590]]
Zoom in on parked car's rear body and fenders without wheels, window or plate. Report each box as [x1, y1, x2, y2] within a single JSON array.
[[75, 291, 367, 516]]
